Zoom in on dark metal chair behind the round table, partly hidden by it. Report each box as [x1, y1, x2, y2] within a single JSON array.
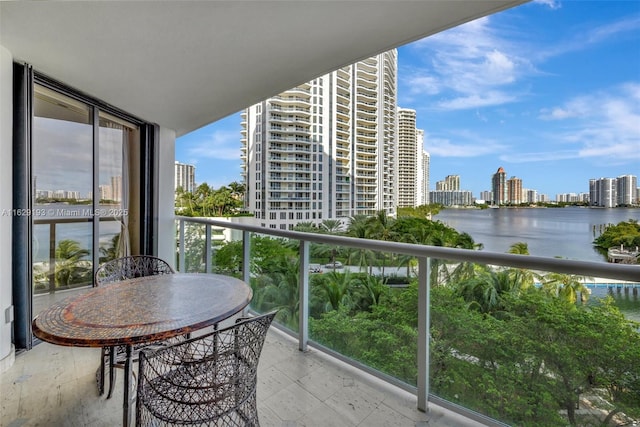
[[93, 255, 175, 399]]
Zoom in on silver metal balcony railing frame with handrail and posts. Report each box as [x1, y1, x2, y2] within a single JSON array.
[[176, 216, 640, 426]]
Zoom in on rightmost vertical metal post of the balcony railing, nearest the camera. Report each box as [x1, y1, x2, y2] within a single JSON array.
[[418, 257, 431, 412]]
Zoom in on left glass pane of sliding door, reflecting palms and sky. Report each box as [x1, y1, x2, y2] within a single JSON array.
[[31, 85, 94, 316]]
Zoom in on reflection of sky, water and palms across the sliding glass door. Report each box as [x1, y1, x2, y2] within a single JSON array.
[[31, 85, 138, 316]]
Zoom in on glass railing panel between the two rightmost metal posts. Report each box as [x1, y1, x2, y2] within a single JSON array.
[[309, 245, 418, 386]]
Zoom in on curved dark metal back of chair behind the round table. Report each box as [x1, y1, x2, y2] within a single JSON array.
[[93, 255, 175, 286]]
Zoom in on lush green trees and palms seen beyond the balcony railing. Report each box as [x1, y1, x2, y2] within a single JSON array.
[[181, 210, 640, 426]]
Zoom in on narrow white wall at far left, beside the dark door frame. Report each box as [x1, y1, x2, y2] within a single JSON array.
[[0, 46, 15, 372]]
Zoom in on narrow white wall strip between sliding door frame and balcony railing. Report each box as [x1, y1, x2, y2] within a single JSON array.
[[158, 128, 176, 268]]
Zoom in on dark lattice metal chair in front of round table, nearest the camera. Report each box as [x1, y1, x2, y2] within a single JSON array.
[[136, 311, 276, 427]]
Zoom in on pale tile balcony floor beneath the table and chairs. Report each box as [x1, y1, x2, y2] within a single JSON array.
[[0, 328, 479, 427]]
